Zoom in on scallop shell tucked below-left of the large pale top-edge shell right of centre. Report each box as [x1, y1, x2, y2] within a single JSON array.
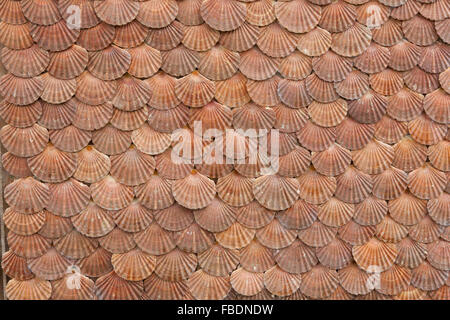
[[256, 23, 298, 58]]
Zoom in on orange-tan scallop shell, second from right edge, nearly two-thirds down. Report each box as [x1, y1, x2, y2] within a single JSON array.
[[389, 192, 427, 226]]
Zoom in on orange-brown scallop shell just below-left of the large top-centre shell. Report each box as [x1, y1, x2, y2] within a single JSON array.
[[182, 23, 220, 51]]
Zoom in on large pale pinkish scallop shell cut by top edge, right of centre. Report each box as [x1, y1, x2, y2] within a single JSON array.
[[274, 0, 322, 33]]
